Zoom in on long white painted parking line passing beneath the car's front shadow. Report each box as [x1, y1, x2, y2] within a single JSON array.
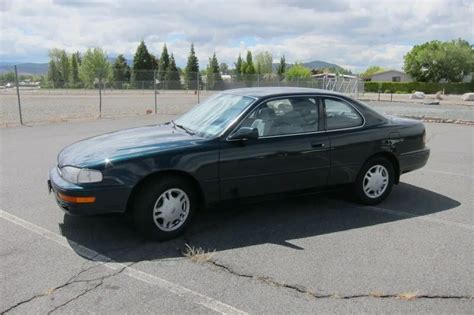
[[0, 210, 247, 314]]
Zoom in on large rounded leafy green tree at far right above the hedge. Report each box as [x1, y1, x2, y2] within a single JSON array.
[[404, 39, 474, 82]]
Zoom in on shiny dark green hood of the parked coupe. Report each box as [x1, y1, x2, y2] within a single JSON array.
[[58, 124, 202, 167]]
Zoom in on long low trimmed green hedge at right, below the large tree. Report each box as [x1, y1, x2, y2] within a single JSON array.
[[364, 82, 474, 94]]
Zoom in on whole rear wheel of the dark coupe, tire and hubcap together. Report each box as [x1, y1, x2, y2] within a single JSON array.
[[353, 157, 395, 205]]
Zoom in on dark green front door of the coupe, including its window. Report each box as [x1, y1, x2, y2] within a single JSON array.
[[219, 96, 330, 199]]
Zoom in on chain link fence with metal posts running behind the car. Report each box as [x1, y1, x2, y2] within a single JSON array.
[[0, 71, 364, 126]]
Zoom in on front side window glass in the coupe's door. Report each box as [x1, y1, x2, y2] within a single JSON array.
[[241, 97, 319, 137]]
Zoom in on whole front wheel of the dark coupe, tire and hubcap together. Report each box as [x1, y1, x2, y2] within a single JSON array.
[[133, 176, 198, 241]]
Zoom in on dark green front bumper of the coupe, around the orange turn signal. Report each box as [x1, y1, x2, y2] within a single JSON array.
[[47, 167, 130, 215]]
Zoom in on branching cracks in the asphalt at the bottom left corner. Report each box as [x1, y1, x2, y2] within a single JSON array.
[[0, 262, 138, 315]]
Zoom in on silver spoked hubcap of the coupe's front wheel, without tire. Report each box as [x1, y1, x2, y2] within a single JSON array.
[[153, 188, 190, 232]]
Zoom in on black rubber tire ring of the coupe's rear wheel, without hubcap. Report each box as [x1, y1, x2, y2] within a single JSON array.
[[354, 157, 395, 205]]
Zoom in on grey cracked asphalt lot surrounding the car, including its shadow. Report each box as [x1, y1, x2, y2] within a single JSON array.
[[0, 116, 474, 314]]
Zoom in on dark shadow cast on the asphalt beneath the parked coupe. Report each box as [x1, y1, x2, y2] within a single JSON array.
[[60, 183, 460, 262]]
